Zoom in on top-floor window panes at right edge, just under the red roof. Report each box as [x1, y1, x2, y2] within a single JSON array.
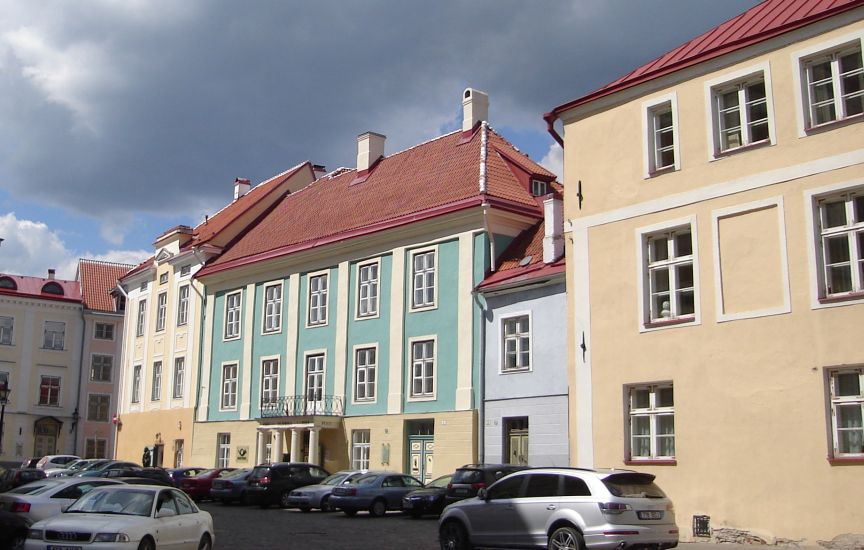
[[801, 40, 864, 128]]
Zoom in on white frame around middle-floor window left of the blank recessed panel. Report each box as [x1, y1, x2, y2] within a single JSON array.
[[635, 216, 702, 332]]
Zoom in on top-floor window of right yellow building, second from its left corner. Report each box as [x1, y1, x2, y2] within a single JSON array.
[[711, 72, 770, 153]]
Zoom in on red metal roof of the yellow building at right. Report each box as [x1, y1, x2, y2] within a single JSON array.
[[544, 0, 864, 120]]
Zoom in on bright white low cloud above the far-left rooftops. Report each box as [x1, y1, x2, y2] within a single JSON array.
[[0, 212, 149, 279]]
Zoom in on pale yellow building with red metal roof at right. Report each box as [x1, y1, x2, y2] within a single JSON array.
[[546, 0, 864, 544]]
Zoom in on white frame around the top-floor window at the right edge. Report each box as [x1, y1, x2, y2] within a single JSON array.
[[792, 31, 864, 137]]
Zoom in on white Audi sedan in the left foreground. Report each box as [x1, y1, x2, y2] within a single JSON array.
[[24, 485, 214, 550]]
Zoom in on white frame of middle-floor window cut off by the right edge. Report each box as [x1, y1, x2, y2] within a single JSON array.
[[804, 178, 864, 309]]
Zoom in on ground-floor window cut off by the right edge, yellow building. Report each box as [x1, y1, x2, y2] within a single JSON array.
[[829, 368, 864, 457]]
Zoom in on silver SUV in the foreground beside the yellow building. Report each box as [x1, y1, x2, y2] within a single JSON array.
[[438, 468, 678, 550]]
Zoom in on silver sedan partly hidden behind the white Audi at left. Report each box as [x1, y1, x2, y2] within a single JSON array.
[[0, 477, 120, 523]]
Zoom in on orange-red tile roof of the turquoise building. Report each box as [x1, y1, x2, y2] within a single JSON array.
[[199, 127, 555, 276]]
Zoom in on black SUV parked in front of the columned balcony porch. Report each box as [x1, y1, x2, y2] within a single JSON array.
[[246, 462, 330, 508]]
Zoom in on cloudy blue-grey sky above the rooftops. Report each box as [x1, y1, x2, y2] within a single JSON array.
[[0, 0, 757, 279]]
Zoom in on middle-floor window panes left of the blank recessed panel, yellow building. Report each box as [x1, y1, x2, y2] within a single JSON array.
[[643, 226, 696, 323]]
